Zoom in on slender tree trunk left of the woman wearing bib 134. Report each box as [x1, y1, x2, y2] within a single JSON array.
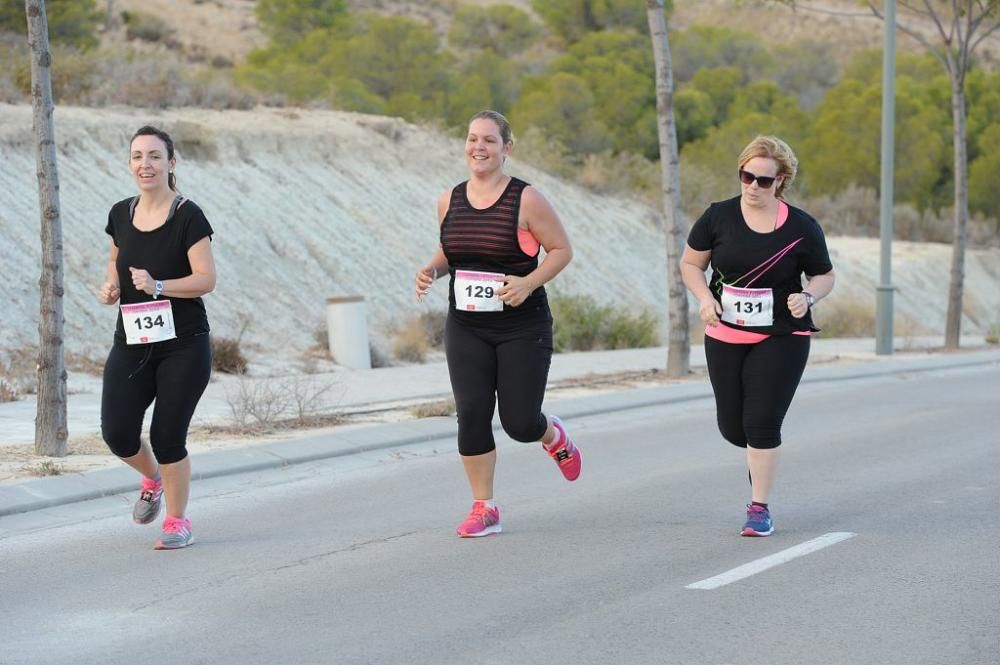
[[24, 0, 68, 457]]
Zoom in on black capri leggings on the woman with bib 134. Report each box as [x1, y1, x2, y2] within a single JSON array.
[[101, 334, 212, 464]]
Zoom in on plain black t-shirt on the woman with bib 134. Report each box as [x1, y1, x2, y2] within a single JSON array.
[[104, 197, 213, 343]]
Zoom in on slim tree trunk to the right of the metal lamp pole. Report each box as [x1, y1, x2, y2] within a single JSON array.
[[944, 77, 969, 351]]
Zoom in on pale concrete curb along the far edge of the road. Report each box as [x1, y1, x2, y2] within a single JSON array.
[[0, 351, 1000, 517]]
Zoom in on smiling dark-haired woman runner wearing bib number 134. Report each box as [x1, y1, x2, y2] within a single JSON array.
[[98, 126, 215, 549]]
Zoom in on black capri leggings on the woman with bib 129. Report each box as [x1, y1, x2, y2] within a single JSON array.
[[444, 306, 552, 456]]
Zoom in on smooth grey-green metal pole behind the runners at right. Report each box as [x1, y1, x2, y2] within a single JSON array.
[[875, 0, 896, 355]]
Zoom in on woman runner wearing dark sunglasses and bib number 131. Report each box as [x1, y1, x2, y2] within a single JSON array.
[[681, 136, 834, 536]]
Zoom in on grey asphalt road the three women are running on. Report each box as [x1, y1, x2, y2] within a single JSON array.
[[0, 365, 1000, 665]]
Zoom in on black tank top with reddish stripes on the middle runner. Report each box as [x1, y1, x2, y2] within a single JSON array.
[[441, 177, 548, 322]]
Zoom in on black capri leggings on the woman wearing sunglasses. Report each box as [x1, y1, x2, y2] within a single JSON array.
[[705, 335, 809, 448]]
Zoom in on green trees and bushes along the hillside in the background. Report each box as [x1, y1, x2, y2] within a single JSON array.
[[0, 0, 1000, 224]]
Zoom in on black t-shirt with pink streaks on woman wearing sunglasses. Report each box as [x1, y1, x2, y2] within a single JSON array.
[[688, 196, 833, 335]]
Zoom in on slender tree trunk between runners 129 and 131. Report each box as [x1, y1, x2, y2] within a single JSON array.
[[646, 0, 691, 378]]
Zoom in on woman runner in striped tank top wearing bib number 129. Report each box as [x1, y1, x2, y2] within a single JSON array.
[[416, 111, 581, 538]]
